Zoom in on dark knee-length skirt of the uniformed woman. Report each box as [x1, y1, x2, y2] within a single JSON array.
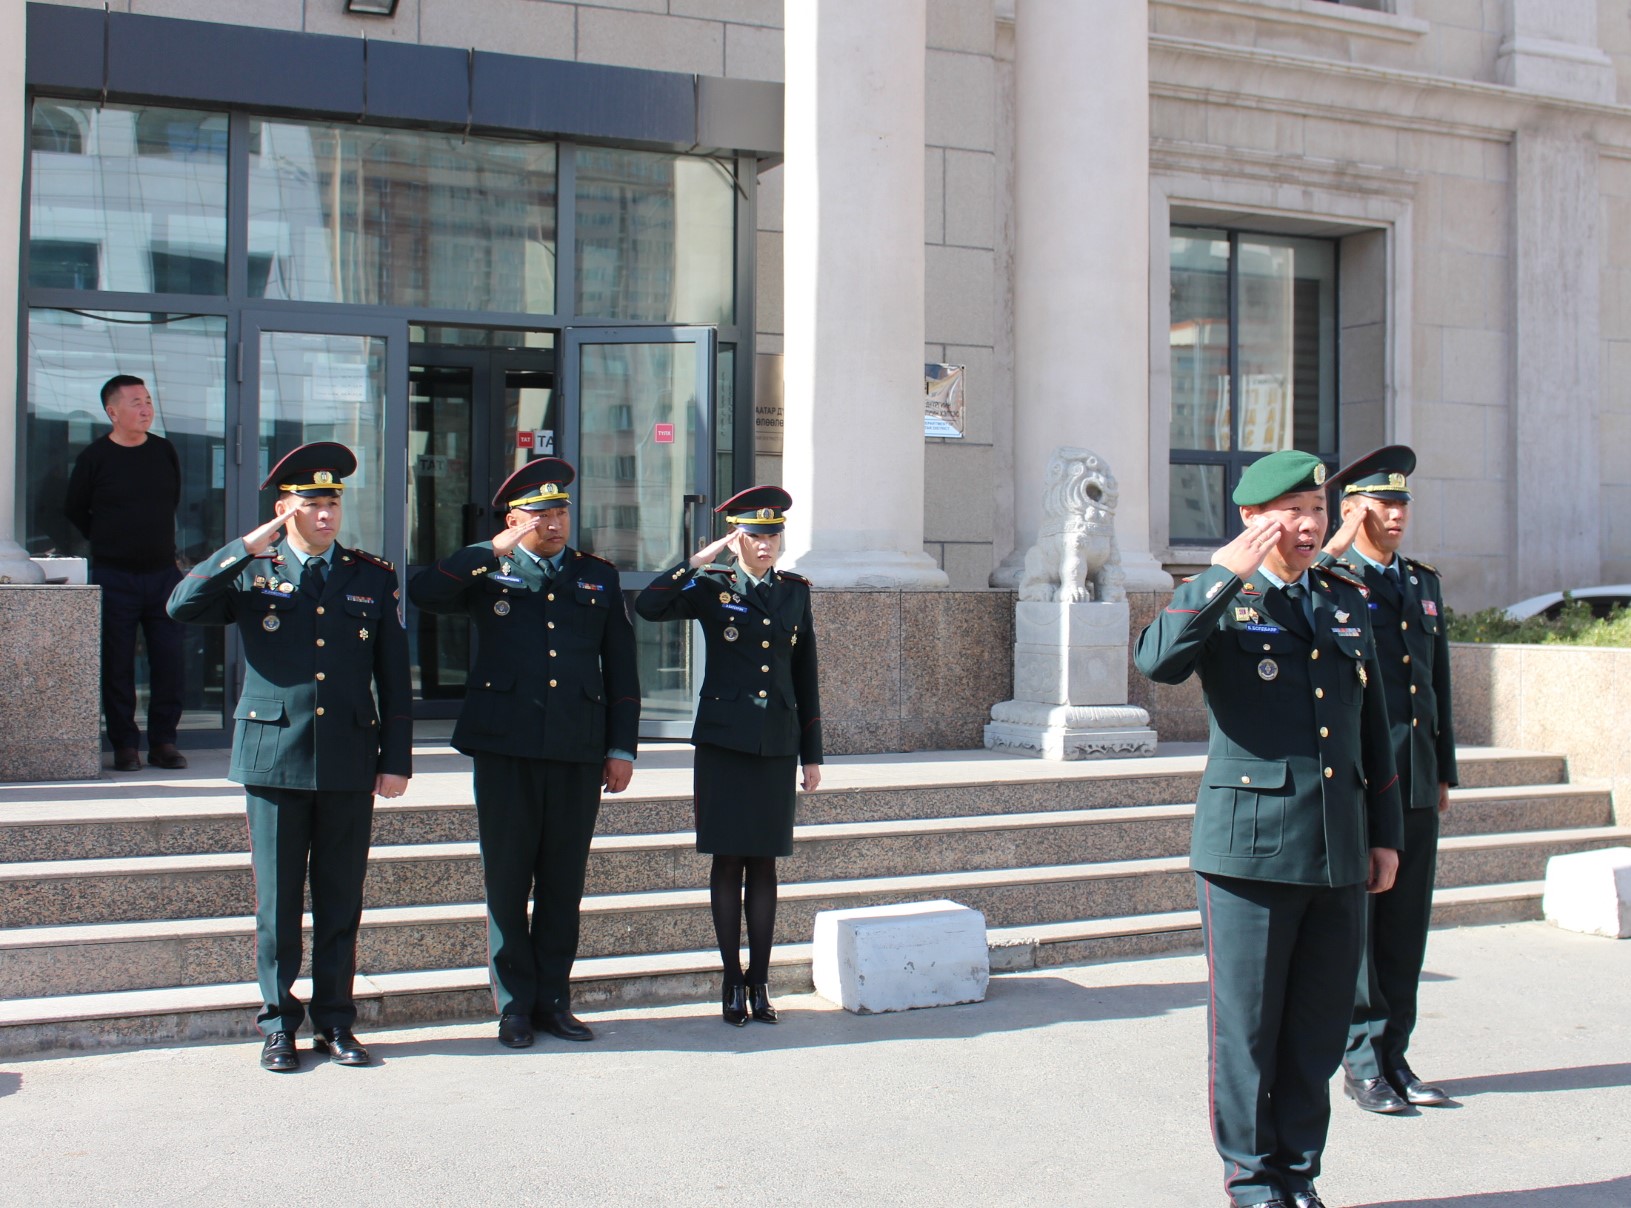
[[695, 743, 799, 856]]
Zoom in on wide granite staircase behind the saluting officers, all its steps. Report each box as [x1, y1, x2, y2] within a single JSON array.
[[0, 747, 1631, 1055]]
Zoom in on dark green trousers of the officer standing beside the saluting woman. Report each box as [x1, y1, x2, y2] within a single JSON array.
[[475, 753, 603, 1016]]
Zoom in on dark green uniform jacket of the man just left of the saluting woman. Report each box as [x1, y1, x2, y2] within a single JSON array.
[[408, 541, 639, 763]]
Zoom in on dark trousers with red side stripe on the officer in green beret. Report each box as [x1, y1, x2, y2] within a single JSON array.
[[1197, 874, 1365, 1205]]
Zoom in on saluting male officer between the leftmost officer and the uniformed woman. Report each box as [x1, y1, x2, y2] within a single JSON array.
[[408, 456, 639, 1048]]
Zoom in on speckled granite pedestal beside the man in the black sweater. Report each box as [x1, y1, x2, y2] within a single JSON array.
[[0, 585, 101, 781]]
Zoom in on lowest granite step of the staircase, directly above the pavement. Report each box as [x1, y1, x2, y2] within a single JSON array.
[[0, 882, 1543, 1058]]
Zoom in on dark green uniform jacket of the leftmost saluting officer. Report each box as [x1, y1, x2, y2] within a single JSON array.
[[170, 540, 413, 792]]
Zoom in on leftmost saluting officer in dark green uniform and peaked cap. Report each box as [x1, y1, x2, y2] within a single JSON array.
[[170, 440, 413, 1073]]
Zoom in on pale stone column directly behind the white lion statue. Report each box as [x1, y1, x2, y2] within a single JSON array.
[[992, 0, 1173, 592]]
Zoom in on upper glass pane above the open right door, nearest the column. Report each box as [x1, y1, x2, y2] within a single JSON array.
[[574, 147, 736, 324]]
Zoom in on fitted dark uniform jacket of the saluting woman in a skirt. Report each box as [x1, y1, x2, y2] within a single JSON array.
[[634, 562, 822, 763]]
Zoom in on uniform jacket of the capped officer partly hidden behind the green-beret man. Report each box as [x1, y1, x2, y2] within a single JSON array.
[[1319, 554, 1458, 810]]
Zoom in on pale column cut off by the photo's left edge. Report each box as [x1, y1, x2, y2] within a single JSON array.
[[0, 3, 44, 584]]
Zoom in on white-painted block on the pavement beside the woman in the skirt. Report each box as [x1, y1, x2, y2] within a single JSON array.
[[814, 900, 992, 1014]]
